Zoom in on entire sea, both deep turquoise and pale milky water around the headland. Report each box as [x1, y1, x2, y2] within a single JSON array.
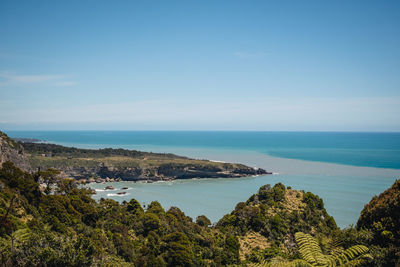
[[6, 131, 400, 227]]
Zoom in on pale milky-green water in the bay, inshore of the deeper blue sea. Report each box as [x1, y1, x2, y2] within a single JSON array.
[[86, 148, 400, 227]]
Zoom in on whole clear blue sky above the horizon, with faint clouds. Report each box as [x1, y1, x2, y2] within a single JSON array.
[[0, 0, 400, 132]]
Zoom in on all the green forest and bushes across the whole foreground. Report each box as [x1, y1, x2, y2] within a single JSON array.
[[0, 159, 398, 266]]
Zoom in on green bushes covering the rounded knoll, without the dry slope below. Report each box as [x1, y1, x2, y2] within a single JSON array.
[[217, 183, 337, 249]]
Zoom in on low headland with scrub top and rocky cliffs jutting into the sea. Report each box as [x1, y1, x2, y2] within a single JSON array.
[[22, 140, 267, 181]]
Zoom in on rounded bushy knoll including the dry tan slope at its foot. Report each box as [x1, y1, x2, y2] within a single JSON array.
[[217, 183, 338, 260]]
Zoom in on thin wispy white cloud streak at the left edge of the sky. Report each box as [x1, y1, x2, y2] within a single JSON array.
[[0, 72, 76, 87]]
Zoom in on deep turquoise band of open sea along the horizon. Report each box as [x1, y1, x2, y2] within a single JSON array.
[[7, 131, 400, 169]]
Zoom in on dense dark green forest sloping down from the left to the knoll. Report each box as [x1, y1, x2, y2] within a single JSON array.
[[0, 163, 239, 266]]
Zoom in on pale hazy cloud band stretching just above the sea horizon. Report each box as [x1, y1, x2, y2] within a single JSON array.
[[0, 97, 400, 131]]
